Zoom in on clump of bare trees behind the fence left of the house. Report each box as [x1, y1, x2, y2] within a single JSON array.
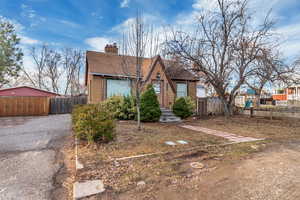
[[19, 45, 84, 95]]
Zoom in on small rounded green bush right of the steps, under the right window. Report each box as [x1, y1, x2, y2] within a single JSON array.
[[172, 97, 193, 119]]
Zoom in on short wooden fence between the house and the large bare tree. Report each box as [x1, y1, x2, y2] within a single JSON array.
[[197, 97, 224, 116]]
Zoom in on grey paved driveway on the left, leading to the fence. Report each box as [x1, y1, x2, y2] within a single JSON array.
[[0, 115, 70, 200]]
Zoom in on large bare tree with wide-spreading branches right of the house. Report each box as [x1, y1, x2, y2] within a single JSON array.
[[166, 0, 274, 116]]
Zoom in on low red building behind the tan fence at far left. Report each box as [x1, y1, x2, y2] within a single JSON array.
[[0, 86, 60, 97]]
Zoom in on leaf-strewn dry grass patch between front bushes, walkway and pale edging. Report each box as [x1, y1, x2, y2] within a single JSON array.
[[79, 121, 226, 161]]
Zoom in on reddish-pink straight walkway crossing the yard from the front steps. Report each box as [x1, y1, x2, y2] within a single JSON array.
[[181, 125, 263, 143]]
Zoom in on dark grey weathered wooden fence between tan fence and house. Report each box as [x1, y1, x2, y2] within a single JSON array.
[[50, 96, 87, 114]]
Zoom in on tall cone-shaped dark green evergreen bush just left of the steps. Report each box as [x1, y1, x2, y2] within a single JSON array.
[[141, 85, 161, 122]]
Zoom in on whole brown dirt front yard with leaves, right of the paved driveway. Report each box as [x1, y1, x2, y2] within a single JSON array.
[[76, 116, 300, 200]]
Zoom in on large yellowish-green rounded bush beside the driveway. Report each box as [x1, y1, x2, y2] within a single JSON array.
[[72, 104, 116, 143]]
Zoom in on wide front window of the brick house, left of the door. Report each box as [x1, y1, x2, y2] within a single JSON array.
[[106, 79, 131, 98]]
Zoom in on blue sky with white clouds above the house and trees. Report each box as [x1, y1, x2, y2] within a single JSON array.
[[0, 0, 300, 62]]
